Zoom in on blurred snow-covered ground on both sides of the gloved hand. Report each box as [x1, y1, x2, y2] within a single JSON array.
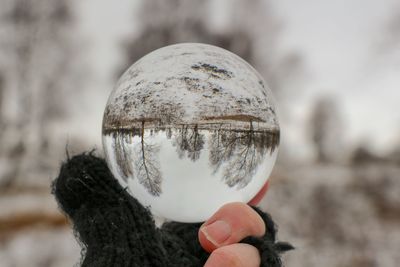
[[0, 163, 400, 267]]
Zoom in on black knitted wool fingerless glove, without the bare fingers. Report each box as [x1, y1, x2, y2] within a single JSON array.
[[53, 153, 293, 267]]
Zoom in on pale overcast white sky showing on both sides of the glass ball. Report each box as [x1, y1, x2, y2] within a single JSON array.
[[77, 0, 400, 158]]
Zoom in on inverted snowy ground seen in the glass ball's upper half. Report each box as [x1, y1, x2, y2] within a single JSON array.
[[103, 43, 278, 132]]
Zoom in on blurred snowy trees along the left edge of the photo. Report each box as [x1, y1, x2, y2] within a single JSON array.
[[0, 0, 79, 186]]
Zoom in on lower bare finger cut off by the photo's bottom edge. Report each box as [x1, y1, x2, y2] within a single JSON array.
[[204, 244, 261, 267]]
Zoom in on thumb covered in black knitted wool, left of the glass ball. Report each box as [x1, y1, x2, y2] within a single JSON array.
[[53, 153, 168, 266]]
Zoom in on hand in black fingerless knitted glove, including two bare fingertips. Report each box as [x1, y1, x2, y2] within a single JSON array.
[[53, 154, 292, 267]]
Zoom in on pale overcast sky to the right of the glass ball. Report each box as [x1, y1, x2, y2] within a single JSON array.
[[274, 0, 400, 155]]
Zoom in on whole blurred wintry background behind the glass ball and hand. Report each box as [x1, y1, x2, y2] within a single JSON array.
[[0, 0, 400, 267]]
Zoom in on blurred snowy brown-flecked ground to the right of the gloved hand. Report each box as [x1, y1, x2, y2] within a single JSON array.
[[262, 165, 400, 267]]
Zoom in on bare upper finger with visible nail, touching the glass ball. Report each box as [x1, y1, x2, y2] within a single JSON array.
[[198, 202, 265, 252]]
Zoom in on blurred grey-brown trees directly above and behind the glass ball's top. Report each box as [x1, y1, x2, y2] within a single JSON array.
[[121, 0, 304, 102]]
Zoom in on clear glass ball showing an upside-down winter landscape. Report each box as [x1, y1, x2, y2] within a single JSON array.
[[102, 43, 280, 222]]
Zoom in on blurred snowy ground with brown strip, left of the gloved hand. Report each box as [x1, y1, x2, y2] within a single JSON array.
[[0, 190, 80, 267]]
